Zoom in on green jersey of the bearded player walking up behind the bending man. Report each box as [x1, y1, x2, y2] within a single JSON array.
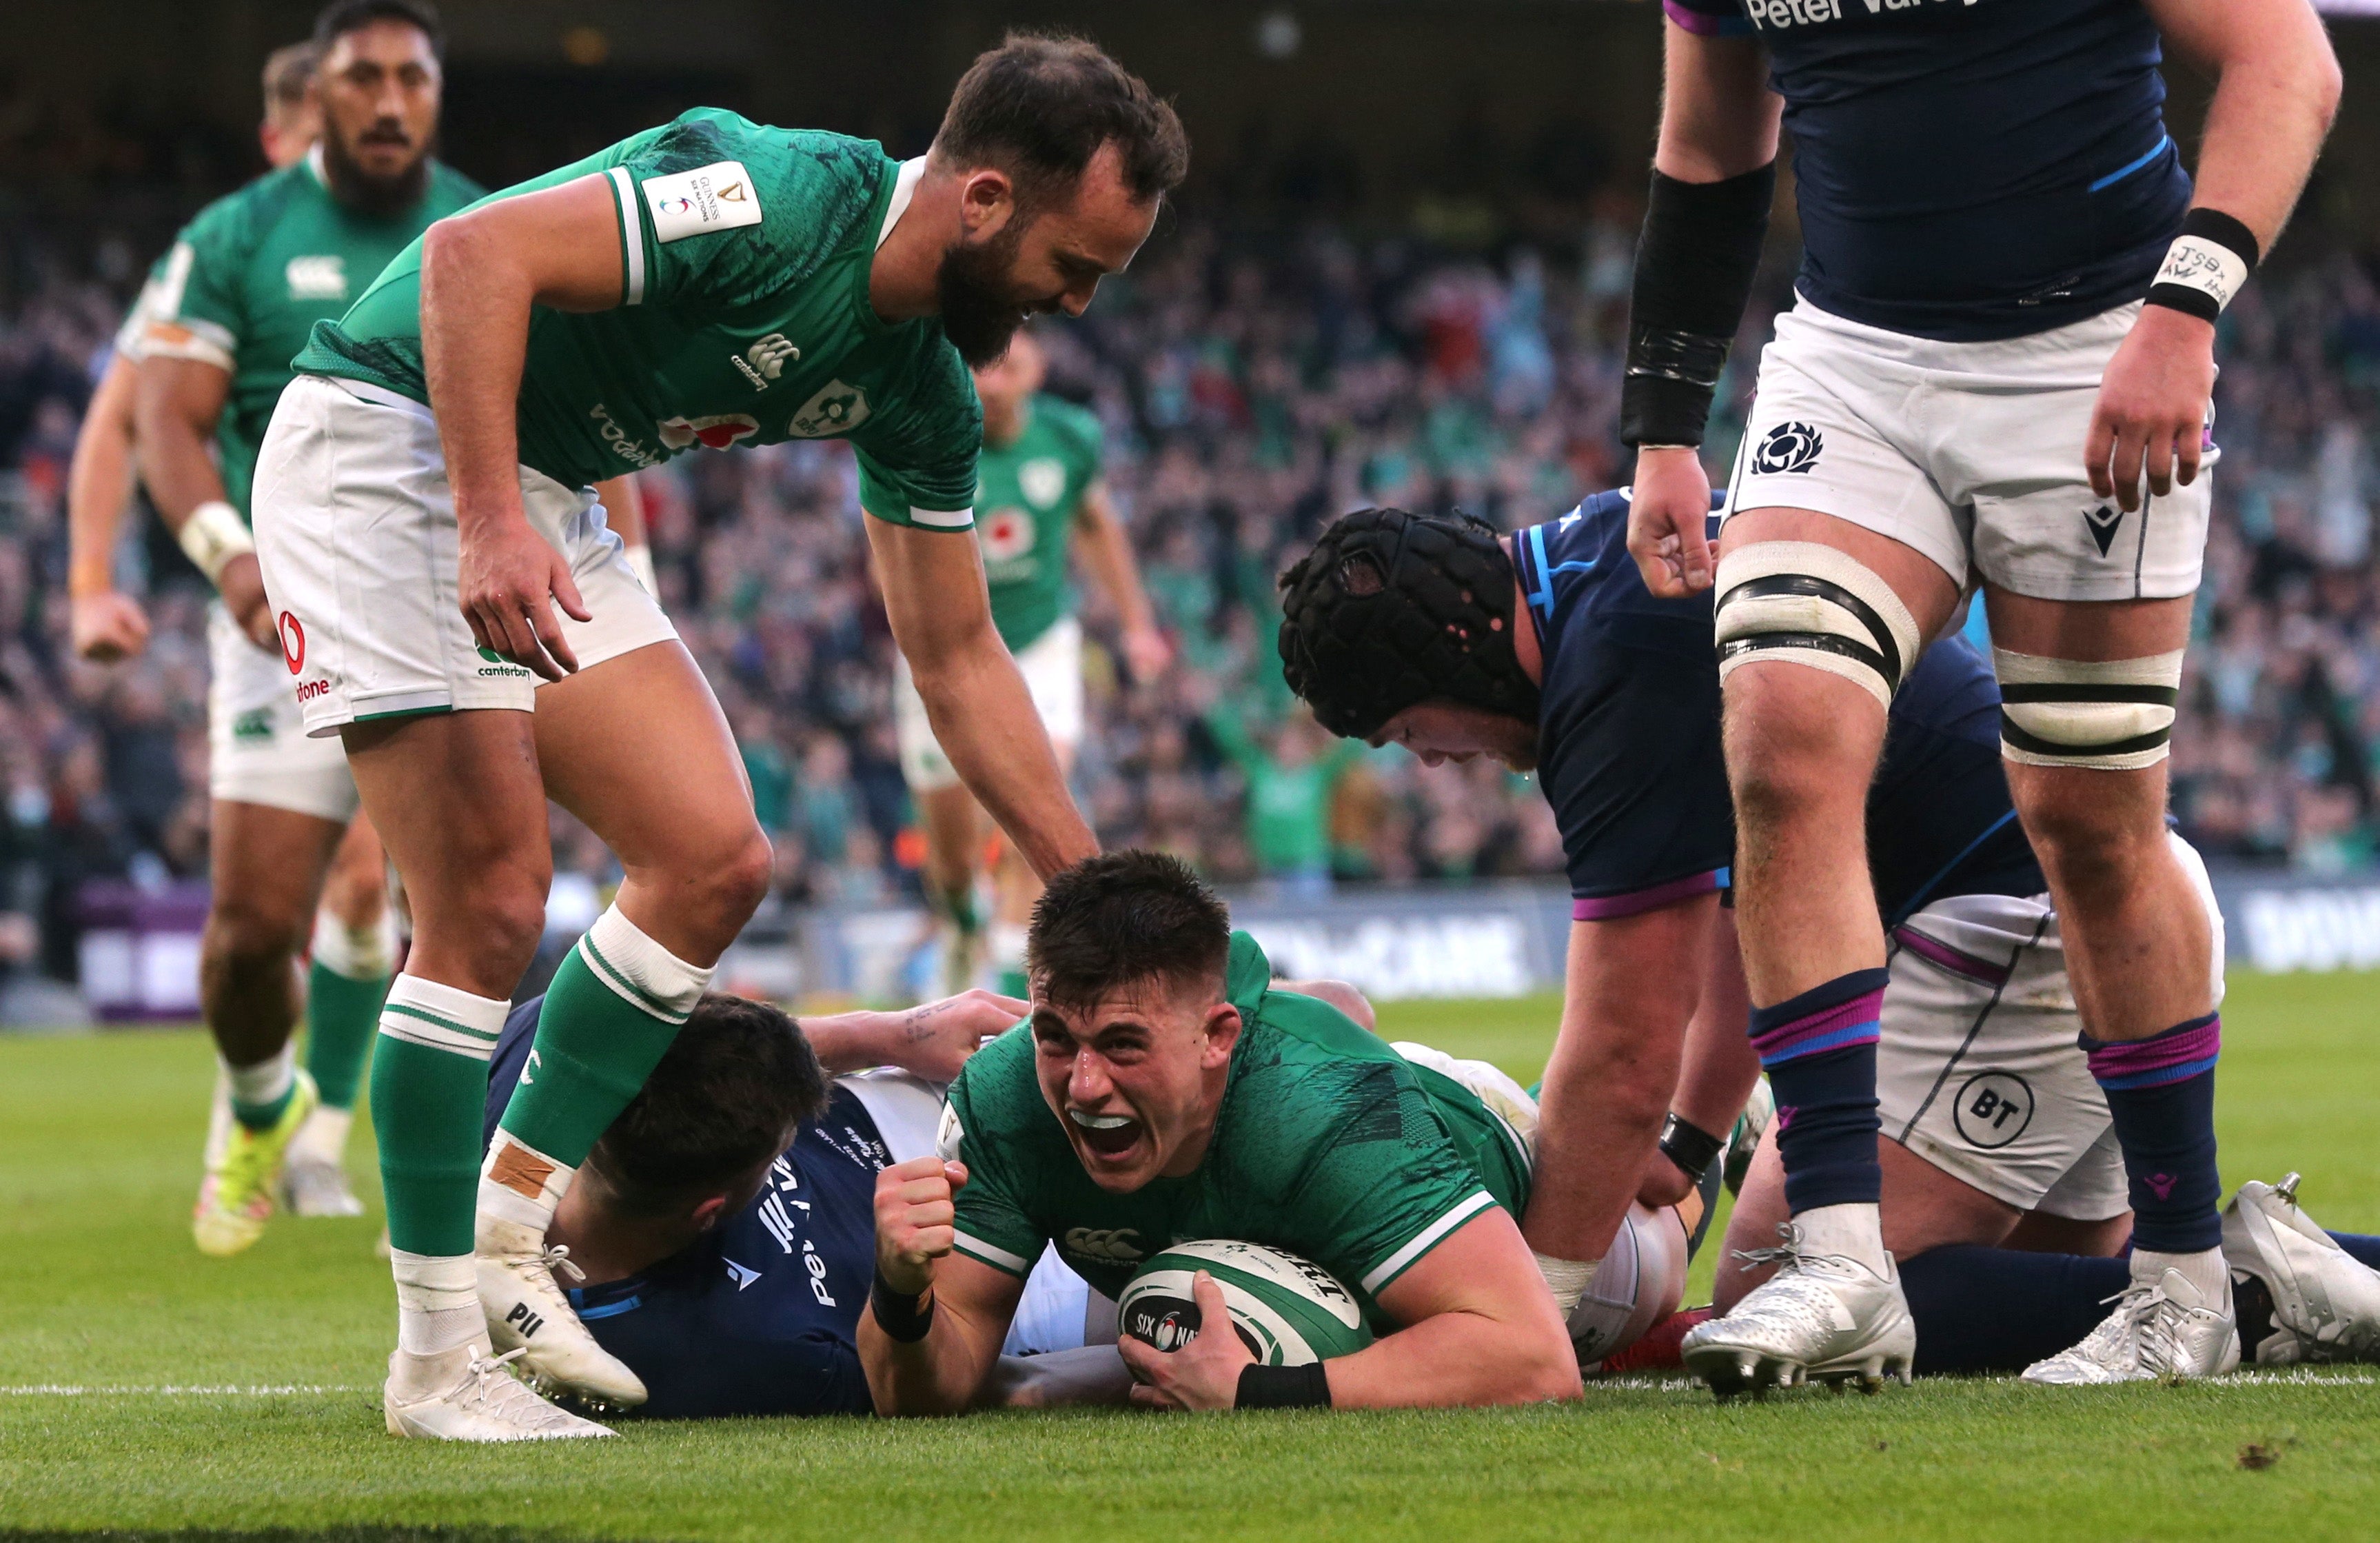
[[138, 150, 483, 516]]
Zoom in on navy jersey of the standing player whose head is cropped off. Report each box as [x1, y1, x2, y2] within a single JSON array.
[[1664, 0, 2190, 343]]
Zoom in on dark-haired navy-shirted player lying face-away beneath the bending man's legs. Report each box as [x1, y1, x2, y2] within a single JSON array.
[[483, 991, 1130, 1419]]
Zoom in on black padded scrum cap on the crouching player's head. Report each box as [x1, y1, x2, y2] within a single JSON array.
[[1278, 510, 1538, 738]]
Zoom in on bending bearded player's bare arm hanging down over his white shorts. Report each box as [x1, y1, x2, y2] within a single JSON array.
[[421, 174, 624, 681]]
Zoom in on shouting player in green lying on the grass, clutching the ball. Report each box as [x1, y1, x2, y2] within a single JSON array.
[[860, 852, 1578, 1415]]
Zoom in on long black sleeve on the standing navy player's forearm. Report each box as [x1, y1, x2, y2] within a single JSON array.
[[1620, 162, 1778, 445]]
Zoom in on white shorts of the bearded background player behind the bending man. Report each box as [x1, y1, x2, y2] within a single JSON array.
[[207, 600, 357, 824]]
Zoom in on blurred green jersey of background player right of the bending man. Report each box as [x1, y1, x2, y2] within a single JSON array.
[[976, 395, 1102, 652]]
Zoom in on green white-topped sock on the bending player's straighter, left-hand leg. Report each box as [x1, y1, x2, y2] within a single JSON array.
[[372, 976, 507, 1258]]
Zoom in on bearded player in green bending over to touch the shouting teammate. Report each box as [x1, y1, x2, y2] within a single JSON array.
[[257, 38, 1188, 1440]]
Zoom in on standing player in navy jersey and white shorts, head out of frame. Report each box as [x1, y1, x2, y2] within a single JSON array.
[[1620, 0, 2339, 1384]]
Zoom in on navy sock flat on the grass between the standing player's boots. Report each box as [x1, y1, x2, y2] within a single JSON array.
[[1899, 1243, 2133, 1376]]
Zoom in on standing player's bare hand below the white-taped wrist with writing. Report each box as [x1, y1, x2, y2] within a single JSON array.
[[2082, 305, 2216, 512]]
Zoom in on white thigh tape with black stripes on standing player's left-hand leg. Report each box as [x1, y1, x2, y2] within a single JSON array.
[[1718, 541, 1921, 707]]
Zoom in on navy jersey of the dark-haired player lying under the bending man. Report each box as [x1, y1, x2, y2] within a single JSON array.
[[483, 998, 893, 1419]]
